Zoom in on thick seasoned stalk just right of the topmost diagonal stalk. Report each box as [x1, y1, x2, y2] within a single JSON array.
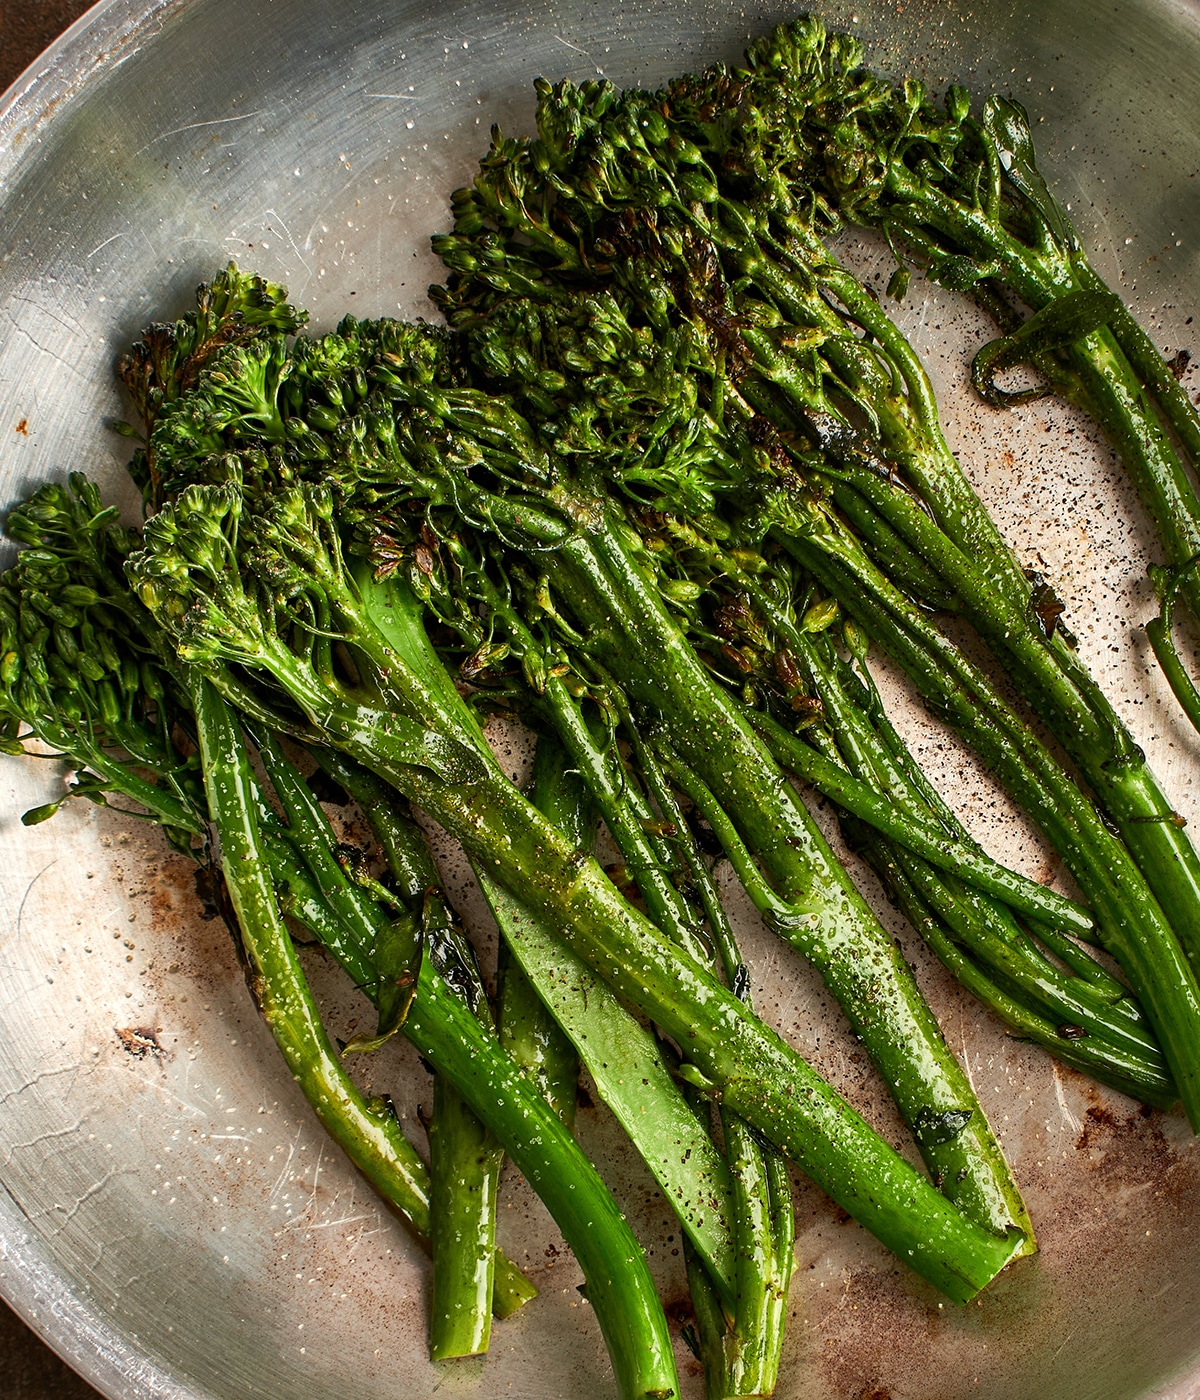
[[548, 526, 1032, 1239]]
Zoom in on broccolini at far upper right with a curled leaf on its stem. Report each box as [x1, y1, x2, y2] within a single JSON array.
[[724, 15, 1200, 728]]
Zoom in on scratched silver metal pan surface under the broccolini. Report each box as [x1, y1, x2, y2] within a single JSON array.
[[7, 0, 1200, 1400]]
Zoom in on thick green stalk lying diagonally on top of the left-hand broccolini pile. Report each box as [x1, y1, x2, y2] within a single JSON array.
[[222, 568, 1025, 1301]]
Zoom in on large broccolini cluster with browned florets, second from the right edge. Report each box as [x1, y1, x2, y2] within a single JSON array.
[[435, 46, 1200, 1121]]
